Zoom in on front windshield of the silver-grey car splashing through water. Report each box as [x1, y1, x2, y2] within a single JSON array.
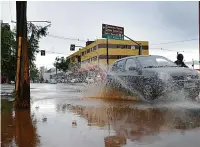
[[138, 56, 177, 68]]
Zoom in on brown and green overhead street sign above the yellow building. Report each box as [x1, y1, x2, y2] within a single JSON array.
[[102, 24, 124, 40]]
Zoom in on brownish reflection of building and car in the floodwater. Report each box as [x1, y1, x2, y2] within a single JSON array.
[[64, 105, 200, 147]]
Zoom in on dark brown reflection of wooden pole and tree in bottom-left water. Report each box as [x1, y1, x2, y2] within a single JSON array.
[[1, 102, 40, 147]]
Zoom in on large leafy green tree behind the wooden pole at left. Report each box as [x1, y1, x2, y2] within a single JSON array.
[[1, 23, 49, 81]]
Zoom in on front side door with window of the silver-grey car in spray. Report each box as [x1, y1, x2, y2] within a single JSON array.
[[123, 58, 140, 91]]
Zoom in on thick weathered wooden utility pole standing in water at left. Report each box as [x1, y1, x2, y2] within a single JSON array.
[[15, 1, 30, 109]]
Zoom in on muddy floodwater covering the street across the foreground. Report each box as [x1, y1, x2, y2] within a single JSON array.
[[1, 84, 200, 147]]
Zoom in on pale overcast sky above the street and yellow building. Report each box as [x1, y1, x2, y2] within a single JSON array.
[[1, 1, 199, 67]]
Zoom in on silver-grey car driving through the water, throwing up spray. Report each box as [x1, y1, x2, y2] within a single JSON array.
[[106, 55, 200, 102]]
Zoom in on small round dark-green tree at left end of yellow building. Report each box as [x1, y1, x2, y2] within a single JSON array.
[[53, 57, 70, 72]]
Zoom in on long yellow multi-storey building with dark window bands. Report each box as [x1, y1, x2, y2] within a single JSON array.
[[67, 39, 149, 67]]
